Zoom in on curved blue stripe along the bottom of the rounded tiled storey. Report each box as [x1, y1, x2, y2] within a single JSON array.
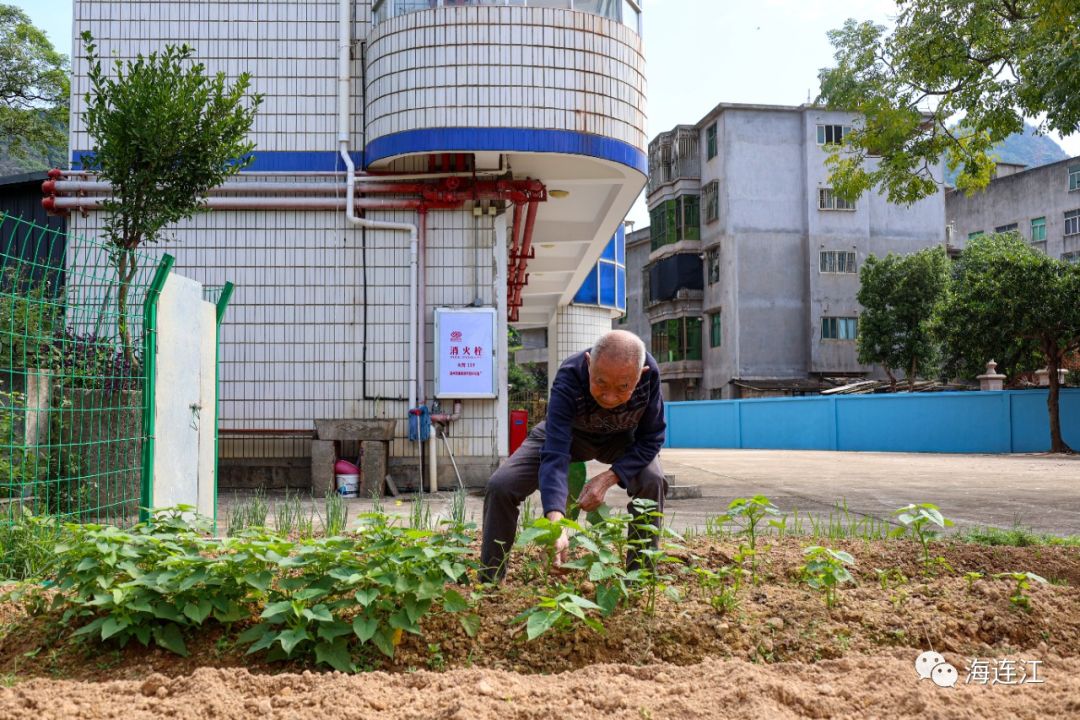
[[366, 127, 649, 175]]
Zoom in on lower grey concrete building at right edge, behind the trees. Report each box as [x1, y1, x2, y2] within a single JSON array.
[[945, 157, 1080, 262]]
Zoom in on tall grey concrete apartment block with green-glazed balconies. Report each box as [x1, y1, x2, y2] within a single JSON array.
[[623, 104, 945, 400]]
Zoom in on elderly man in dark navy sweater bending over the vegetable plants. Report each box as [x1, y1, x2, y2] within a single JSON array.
[[481, 330, 667, 581]]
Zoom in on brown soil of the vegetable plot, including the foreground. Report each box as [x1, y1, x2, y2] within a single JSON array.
[[0, 539, 1080, 720]]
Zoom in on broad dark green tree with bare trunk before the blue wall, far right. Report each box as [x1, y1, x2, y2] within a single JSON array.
[[939, 233, 1080, 452]]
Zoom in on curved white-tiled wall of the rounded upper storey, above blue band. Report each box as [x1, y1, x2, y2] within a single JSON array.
[[367, 8, 646, 149]]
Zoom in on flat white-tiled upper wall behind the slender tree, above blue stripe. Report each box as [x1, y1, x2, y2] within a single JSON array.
[[71, 0, 370, 151]]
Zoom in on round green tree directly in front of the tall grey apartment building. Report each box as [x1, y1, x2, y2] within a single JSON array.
[[856, 247, 948, 392]]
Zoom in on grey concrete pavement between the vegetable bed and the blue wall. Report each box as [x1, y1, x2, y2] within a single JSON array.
[[219, 450, 1080, 535]]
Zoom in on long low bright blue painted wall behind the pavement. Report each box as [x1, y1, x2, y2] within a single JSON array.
[[664, 389, 1080, 453]]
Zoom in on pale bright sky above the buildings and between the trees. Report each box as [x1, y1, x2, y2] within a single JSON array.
[[14, 0, 1080, 228]]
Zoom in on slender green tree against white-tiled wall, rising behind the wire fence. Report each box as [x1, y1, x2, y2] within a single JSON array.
[[82, 32, 262, 367]]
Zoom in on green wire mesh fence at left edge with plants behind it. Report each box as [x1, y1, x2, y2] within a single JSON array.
[[0, 213, 169, 525]]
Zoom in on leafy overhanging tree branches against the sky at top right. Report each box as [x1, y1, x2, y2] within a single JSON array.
[[818, 0, 1080, 204]]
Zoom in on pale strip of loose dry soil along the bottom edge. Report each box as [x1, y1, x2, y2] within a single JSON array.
[[0, 651, 1080, 720]]
